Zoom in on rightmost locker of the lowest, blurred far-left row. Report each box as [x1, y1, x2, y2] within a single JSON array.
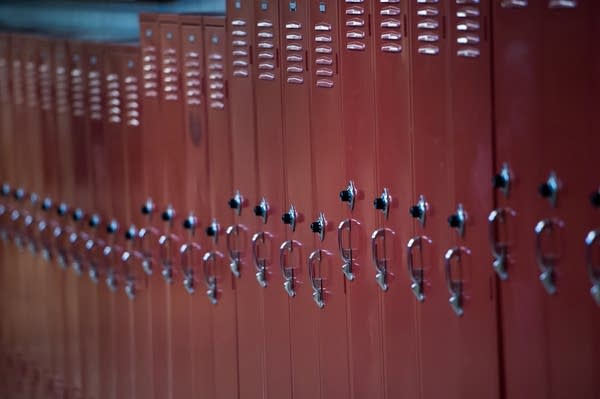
[[120, 46, 154, 398]]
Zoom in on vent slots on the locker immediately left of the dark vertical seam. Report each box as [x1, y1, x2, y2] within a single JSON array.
[[456, 0, 481, 58]]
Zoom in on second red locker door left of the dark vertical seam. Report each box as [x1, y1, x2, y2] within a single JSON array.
[[405, 1, 461, 398]]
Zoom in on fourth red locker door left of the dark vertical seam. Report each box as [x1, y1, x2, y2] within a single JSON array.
[[336, 0, 384, 397]]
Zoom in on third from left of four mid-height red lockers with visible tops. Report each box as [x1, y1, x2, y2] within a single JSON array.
[[179, 14, 215, 397]]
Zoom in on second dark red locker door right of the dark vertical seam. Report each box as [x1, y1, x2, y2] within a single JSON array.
[[540, 1, 600, 398]]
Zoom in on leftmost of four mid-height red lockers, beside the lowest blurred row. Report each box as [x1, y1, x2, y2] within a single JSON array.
[[138, 14, 168, 398]]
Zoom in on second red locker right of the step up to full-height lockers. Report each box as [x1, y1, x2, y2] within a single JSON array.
[[252, 0, 291, 398]]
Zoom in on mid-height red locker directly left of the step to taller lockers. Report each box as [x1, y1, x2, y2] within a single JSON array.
[[200, 16, 239, 399]]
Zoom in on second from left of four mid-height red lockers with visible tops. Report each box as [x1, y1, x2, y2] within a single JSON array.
[[159, 14, 193, 398]]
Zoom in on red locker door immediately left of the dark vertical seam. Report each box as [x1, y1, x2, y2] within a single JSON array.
[[446, 1, 500, 398]]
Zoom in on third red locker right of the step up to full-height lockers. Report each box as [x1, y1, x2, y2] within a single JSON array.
[[278, 0, 320, 398]]
